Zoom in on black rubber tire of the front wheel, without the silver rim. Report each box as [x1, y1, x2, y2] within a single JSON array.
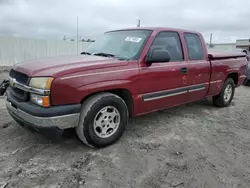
[[76, 92, 129, 148]]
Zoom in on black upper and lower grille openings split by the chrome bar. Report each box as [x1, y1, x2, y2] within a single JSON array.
[[10, 69, 29, 102]]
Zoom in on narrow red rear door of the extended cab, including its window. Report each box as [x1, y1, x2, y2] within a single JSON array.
[[184, 33, 210, 102]]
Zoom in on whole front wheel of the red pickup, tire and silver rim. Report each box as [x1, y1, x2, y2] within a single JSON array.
[[76, 93, 128, 148]]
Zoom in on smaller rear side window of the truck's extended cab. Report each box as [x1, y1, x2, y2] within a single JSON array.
[[184, 33, 204, 60]]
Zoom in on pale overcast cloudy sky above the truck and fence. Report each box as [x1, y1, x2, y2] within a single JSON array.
[[0, 0, 250, 42]]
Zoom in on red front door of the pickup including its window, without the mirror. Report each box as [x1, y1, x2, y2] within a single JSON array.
[[139, 31, 187, 113]]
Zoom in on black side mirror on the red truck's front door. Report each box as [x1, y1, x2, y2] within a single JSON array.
[[146, 50, 170, 63]]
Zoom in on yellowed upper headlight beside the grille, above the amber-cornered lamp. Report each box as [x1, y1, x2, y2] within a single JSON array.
[[29, 77, 54, 89]]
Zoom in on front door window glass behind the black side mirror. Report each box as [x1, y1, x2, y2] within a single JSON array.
[[150, 31, 184, 62]]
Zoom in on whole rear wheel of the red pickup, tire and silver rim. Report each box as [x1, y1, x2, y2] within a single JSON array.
[[213, 78, 235, 107]]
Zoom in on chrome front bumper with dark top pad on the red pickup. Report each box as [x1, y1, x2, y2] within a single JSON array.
[[6, 90, 81, 129]]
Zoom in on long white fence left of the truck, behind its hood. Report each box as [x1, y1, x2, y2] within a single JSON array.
[[0, 37, 90, 66]]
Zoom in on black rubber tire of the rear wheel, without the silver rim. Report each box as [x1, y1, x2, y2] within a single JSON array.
[[213, 78, 235, 107]]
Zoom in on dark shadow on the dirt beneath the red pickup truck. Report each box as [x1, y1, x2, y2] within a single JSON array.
[[13, 99, 219, 149]]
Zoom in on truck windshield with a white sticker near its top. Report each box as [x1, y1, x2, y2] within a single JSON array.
[[86, 29, 152, 59]]
